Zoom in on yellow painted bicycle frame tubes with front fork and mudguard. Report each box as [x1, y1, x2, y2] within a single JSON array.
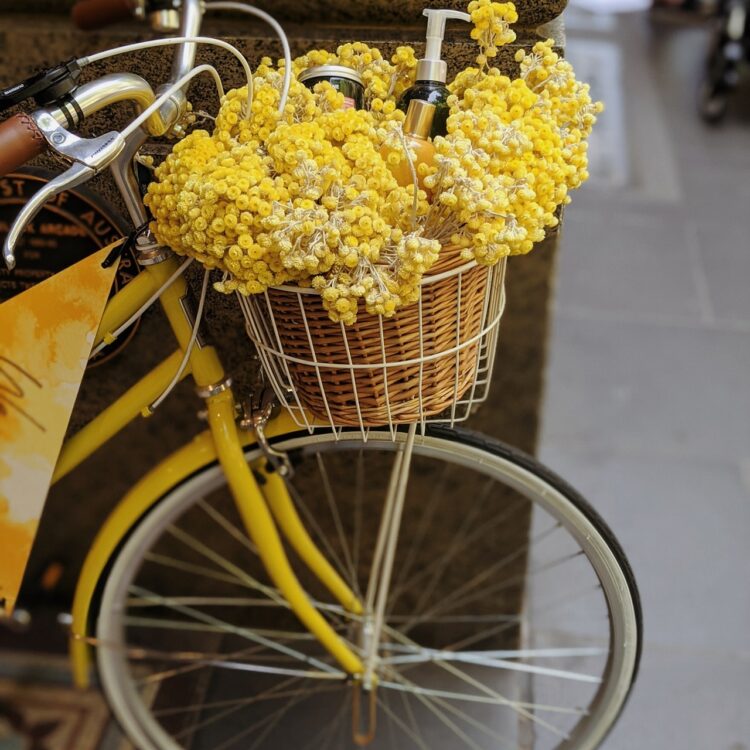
[[53, 257, 364, 687]]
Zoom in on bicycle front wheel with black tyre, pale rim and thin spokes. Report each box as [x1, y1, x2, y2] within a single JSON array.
[[97, 427, 641, 750]]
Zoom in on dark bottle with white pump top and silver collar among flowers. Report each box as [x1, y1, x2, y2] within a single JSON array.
[[398, 8, 471, 138]]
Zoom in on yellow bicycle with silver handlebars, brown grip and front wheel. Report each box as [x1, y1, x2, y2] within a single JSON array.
[[0, 0, 641, 750]]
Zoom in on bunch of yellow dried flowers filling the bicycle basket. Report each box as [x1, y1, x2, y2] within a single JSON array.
[[146, 0, 601, 324]]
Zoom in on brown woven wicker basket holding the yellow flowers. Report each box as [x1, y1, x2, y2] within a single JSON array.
[[256, 247, 500, 427]]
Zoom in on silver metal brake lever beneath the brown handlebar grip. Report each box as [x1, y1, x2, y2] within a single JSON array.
[[3, 110, 125, 270]]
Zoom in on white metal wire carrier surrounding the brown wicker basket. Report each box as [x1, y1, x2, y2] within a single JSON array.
[[237, 258, 506, 440]]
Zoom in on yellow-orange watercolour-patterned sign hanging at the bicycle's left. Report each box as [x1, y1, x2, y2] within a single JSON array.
[[0, 246, 117, 612]]
